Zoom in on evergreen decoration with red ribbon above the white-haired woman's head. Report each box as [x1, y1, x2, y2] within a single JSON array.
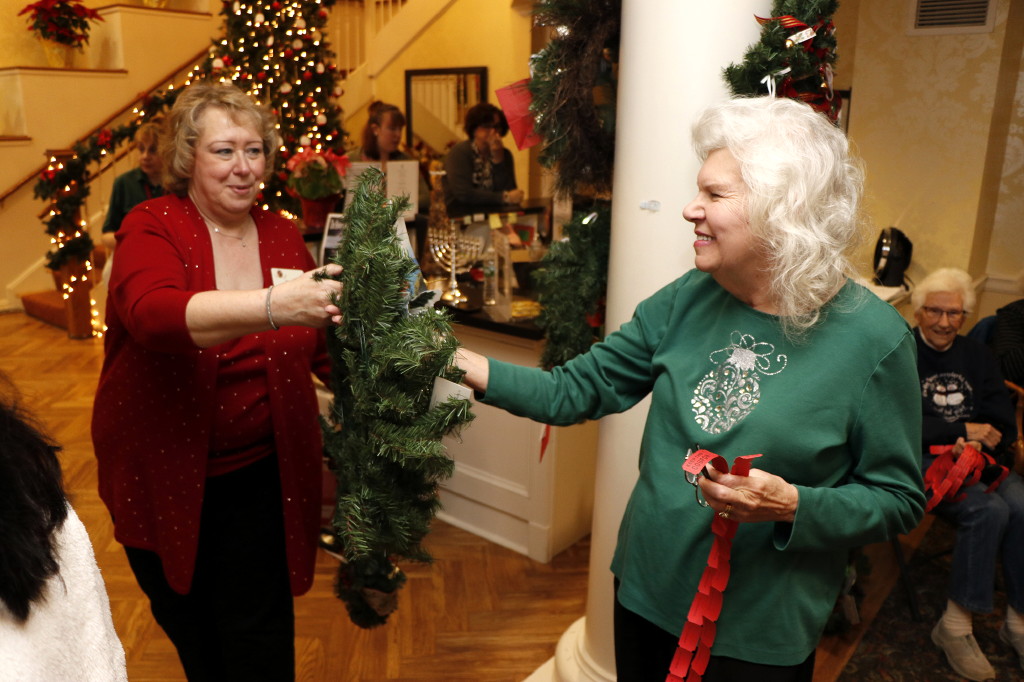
[[725, 0, 840, 122]]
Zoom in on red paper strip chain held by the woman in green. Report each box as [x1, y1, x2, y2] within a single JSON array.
[[665, 450, 761, 682]]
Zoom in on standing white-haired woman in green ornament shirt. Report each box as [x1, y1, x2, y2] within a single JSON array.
[[452, 98, 924, 682]]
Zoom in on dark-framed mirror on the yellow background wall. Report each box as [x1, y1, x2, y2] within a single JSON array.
[[406, 67, 487, 157]]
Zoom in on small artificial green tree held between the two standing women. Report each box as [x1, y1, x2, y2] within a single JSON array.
[[324, 169, 473, 628]]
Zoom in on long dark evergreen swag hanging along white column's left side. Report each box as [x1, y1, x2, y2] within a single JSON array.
[[529, 0, 622, 369]]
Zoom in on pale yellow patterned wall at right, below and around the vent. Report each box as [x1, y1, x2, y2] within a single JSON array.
[[850, 0, 1024, 301]]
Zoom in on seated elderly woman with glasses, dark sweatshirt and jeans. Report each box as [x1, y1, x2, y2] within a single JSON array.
[[912, 268, 1024, 680]]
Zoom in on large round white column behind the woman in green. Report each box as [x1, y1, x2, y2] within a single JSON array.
[[529, 0, 771, 682]]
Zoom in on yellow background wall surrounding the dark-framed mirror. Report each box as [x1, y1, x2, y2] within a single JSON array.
[[345, 0, 531, 187]]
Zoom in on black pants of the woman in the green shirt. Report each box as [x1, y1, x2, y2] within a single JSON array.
[[614, 579, 814, 682]]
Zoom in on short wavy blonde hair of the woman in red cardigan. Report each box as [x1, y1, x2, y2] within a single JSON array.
[[160, 83, 281, 196]]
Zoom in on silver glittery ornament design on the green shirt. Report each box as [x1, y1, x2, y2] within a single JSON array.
[[690, 331, 788, 433]]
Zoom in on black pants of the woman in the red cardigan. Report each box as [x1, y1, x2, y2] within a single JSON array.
[[125, 456, 295, 682]]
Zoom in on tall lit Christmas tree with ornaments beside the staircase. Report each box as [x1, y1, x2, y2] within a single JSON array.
[[203, 0, 343, 214]]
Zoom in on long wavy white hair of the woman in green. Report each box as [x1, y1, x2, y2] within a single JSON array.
[[693, 97, 863, 338]]
